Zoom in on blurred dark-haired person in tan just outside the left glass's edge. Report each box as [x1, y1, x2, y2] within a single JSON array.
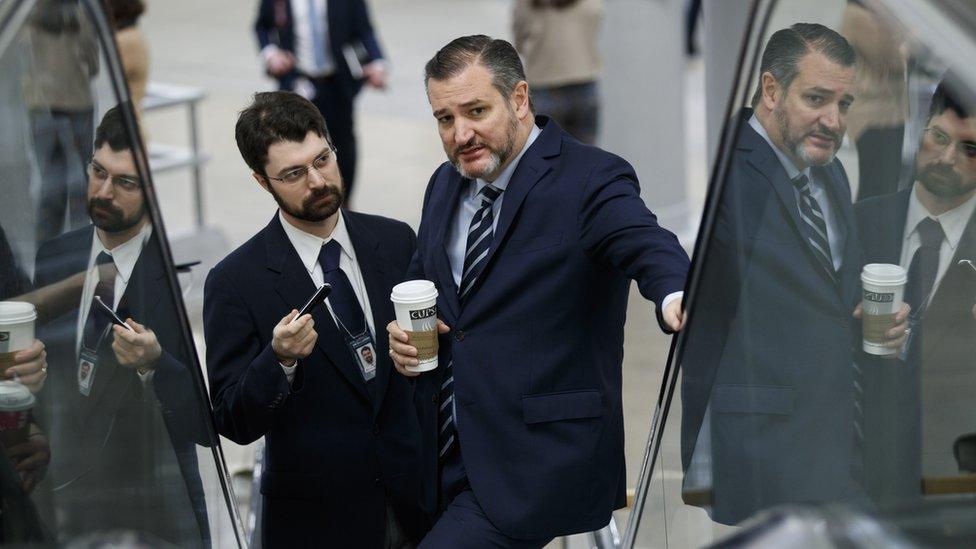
[[106, 0, 149, 108]]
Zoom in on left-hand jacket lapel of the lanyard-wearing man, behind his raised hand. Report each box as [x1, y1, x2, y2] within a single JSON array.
[[265, 215, 369, 402]]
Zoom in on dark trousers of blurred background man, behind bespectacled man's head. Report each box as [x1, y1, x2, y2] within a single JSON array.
[[312, 76, 357, 200]]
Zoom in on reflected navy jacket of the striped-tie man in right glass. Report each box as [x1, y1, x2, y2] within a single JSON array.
[[680, 109, 861, 524]]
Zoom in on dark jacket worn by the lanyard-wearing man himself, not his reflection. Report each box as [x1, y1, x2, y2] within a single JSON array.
[[203, 211, 425, 547]]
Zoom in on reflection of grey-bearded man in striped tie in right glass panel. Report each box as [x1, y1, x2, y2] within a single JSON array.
[[681, 23, 905, 524]]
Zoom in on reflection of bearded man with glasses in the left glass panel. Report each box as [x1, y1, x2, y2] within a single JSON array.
[[35, 108, 208, 544]]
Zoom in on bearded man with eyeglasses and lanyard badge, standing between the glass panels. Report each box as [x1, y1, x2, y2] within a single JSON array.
[[203, 91, 426, 549]]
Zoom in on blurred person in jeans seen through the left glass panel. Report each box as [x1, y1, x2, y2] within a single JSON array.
[[24, 0, 99, 243]]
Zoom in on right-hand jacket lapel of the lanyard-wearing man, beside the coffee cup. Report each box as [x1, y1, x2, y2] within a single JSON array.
[[343, 212, 399, 415]]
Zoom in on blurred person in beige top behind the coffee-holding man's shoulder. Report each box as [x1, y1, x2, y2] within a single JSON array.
[[512, 0, 604, 145]]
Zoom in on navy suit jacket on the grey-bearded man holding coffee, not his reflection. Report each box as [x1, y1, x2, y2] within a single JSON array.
[[409, 117, 688, 538]]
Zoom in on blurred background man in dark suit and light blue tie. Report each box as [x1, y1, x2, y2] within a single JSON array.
[[254, 0, 387, 203]]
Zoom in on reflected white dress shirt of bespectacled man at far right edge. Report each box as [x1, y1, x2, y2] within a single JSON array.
[[901, 186, 976, 303]]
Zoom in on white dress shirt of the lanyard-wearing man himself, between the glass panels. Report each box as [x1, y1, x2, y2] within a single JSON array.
[[278, 210, 376, 383]]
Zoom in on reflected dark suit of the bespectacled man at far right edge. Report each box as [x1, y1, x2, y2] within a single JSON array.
[[855, 188, 976, 504]]
